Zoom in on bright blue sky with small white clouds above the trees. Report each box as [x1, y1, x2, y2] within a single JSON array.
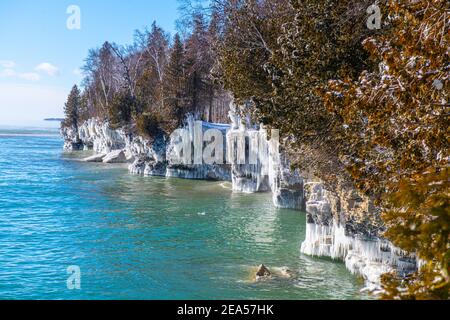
[[0, 0, 178, 126]]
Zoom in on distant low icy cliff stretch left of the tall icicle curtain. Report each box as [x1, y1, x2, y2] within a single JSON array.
[[61, 117, 231, 181]]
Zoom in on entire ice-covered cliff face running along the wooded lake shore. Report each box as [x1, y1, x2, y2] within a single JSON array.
[[61, 105, 420, 289]]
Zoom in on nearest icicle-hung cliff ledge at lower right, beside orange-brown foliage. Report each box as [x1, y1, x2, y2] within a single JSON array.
[[301, 183, 417, 291]]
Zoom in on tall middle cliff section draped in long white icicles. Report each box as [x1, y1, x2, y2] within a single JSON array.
[[226, 104, 304, 210]]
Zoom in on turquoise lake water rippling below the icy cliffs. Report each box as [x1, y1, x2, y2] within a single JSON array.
[[0, 129, 365, 299]]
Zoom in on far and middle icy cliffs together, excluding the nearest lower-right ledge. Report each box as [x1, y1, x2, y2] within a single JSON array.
[[61, 111, 304, 210]]
